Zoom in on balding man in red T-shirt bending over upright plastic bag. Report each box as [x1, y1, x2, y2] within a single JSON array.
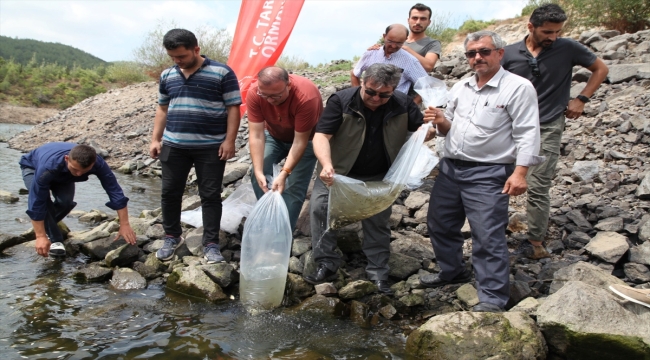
[[246, 66, 323, 231]]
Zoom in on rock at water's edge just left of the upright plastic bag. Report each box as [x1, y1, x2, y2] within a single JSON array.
[[167, 266, 228, 302]]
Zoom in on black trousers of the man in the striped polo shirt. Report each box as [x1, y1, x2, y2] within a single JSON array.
[[160, 146, 226, 245]]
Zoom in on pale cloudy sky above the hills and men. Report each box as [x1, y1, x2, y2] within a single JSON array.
[[0, 0, 528, 65]]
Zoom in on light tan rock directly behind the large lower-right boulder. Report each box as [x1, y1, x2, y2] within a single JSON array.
[[549, 261, 625, 294]]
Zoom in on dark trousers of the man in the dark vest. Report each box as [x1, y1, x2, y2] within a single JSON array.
[[309, 174, 392, 280]]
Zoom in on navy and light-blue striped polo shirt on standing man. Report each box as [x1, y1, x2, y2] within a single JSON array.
[[158, 56, 242, 148]]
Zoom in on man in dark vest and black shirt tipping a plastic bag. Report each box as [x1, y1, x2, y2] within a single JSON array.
[[305, 64, 434, 294]]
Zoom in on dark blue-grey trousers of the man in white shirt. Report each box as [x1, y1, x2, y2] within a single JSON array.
[[427, 158, 514, 307]]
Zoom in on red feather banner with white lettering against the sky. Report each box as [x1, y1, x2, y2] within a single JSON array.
[[228, 0, 305, 114]]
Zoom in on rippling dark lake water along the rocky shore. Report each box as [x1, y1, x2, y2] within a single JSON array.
[[0, 124, 410, 360]]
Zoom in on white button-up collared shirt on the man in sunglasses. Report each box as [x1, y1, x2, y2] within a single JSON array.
[[445, 68, 545, 166]]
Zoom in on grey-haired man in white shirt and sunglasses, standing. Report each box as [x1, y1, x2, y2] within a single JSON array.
[[420, 31, 544, 312]]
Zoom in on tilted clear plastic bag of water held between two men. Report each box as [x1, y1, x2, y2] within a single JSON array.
[[327, 124, 435, 229]]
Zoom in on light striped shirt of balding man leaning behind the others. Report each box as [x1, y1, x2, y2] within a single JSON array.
[[353, 47, 427, 94]]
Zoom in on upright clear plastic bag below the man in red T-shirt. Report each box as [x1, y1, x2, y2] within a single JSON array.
[[239, 166, 292, 314]]
